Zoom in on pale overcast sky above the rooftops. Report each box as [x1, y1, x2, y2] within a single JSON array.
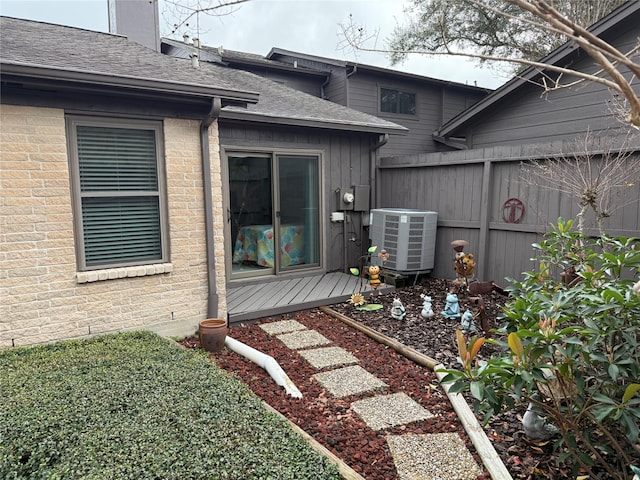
[[0, 0, 508, 88]]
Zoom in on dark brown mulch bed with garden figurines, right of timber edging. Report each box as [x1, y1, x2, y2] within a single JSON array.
[[331, 277, 575, 480]]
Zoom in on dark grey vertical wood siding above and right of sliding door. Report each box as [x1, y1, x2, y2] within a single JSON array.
[[219, 120, 378, 272]]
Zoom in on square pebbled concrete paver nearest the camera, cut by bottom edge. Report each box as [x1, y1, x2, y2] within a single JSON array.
[[387, 433, 482, 480]]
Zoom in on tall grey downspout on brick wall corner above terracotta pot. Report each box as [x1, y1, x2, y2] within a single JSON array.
[[200, 97, 222, 318]]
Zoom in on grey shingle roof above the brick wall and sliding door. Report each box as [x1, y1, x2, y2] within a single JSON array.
[[0, 17, 406, 133]]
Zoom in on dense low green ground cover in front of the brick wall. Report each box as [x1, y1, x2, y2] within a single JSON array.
[[0, 332, 340, 480]]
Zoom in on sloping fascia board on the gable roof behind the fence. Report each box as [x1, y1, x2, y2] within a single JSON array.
[[435, 1, 640, 137]]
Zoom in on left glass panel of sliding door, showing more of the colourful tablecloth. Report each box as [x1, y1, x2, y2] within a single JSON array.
[[227, 155, 276, 276]]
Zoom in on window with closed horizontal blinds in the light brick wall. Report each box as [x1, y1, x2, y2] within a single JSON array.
[[69, 118, 167, 270]]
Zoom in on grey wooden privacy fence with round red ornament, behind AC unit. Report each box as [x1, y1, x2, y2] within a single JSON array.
[[375, 142, 640, 285]]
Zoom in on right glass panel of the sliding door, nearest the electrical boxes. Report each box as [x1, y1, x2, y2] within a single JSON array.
[[276, 155, 320, 270]]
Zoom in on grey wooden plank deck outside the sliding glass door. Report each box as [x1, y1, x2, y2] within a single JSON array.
[[227, 272, 394, 325]]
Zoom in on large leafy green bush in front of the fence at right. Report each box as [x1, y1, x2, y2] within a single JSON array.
[[445, 219, 640, 479]]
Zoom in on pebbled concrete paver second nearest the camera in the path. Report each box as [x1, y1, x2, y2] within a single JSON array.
[[351, 393, 433, 431]]
